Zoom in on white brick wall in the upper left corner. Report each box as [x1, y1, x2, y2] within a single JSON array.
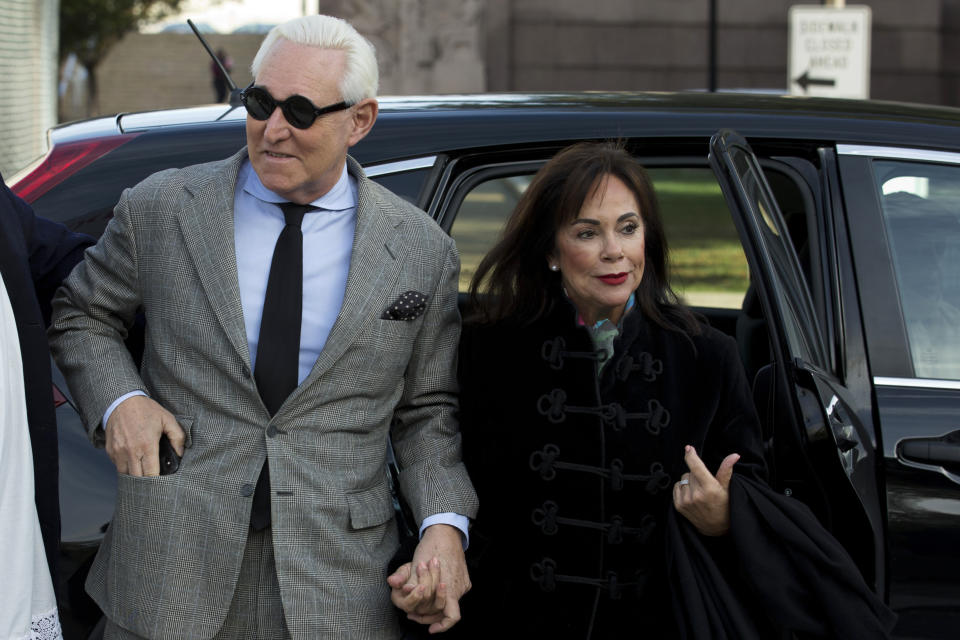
[[0, 0, 59, 179]]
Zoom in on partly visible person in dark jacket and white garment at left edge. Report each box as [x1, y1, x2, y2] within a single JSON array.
[[0, 178, 93, 640]]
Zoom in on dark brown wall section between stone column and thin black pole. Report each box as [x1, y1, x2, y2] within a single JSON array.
[[487, 0, 730, 91]]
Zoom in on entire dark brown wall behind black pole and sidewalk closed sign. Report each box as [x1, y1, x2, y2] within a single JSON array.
[[485, 0, 960, 105]]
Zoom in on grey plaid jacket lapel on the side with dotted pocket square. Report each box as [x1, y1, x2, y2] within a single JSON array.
[[291, 157, 409, 392]]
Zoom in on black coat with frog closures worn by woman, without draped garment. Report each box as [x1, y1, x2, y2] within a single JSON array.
[[460, 303, 764, 638]]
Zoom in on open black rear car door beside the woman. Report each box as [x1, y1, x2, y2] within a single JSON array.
[[709, 130, 885, 595]]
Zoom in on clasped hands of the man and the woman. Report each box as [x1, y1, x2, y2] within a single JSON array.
[[387, 524, 471, 633]]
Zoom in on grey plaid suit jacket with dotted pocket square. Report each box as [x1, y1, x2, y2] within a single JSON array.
[[50, 150, 477, 640]]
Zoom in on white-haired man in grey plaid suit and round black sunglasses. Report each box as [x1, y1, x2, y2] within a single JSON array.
[[51, 16, 477, 640]]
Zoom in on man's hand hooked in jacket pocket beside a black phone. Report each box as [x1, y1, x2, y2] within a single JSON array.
[[106, 396, 186, 476]]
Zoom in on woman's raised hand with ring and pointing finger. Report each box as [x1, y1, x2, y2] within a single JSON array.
[[673, 445, 740, 536]]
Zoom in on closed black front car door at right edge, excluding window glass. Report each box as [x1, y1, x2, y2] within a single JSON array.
[[837, 145, 960, 637]]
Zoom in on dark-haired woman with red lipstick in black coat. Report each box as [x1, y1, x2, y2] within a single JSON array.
[[459, 143, 892, 639]]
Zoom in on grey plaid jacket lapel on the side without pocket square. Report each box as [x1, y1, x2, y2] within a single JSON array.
[[179, 149, 250, 367]]
